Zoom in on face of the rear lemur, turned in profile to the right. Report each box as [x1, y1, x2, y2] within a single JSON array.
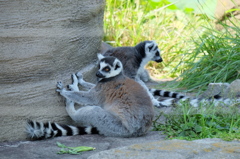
[[145, 41, 163, 62]]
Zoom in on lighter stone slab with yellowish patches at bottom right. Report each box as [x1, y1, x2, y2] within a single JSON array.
[[88, 139, 240, 159]]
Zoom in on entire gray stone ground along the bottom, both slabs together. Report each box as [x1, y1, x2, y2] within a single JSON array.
[[0, 131, 240, 159]]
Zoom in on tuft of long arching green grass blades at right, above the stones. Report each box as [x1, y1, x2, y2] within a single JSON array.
[[164, 23, 240, 91]]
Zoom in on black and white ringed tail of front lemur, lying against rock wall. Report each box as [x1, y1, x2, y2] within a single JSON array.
[[26, 120, 99, 139]]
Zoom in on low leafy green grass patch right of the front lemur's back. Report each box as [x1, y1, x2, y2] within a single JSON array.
[[154, 104, 240, 141]]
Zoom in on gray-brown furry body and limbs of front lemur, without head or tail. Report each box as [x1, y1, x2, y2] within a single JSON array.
[[58, 55, 154, 137]]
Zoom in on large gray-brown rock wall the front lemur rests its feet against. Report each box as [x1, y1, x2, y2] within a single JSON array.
[[0, 0, 105, 141]]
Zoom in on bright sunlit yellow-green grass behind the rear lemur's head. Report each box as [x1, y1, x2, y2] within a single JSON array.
[[104, 0, 211, 78]]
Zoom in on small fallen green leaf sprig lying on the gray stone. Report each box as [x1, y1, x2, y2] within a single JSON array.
[[57, 142, 95, 155]]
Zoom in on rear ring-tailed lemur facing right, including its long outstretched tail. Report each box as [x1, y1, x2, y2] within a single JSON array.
[[74, 41, 238, 107]]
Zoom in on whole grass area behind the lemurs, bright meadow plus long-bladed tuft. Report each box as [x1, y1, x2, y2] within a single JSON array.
[[104, 0, 240, 91]]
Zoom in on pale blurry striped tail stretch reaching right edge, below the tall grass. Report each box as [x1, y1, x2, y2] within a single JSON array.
[[159, 97, 240, 107]]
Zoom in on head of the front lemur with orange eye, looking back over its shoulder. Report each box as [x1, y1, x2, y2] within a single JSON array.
[[96, 54, 123, 79]]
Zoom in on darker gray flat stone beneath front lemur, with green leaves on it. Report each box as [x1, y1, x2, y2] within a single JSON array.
[[0, 132, 164, 159]]
